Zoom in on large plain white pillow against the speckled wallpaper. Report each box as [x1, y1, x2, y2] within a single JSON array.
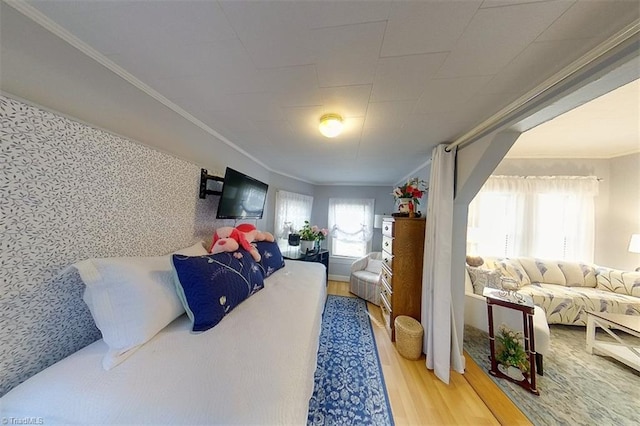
[[73, 255, 184, 370]]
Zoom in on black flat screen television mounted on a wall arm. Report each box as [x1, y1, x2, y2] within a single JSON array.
[[216, 167, 269, 219]]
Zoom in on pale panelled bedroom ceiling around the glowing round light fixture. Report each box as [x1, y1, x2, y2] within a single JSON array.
[[3, 0, 640, 185]]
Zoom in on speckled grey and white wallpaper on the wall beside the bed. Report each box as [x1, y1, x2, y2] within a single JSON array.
[[0, 96, 229, 395]]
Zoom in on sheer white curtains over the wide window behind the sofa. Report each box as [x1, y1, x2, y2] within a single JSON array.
[[467, 176, 598, 262]]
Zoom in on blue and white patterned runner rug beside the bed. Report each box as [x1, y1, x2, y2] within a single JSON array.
[[307, 295, 394, 425]]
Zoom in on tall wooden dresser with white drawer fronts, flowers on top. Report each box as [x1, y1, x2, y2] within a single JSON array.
[[380, 217, 426, 341]]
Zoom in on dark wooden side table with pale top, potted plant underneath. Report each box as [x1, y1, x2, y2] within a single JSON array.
[[482, 287, 540, 395]]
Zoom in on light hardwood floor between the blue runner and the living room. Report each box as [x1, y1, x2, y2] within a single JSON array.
[[327, 281, 531, 425]]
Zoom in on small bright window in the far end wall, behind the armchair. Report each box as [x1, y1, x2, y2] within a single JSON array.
[[328, 198, 374, 257]]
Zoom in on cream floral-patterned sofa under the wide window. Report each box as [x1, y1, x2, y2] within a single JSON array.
[[467, 257, 640, 325]]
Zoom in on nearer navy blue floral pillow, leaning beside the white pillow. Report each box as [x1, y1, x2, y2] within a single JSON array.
[[172, 249, 264, 331]]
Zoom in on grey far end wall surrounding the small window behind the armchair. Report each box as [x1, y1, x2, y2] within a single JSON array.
[[311, 186, 395, 280]]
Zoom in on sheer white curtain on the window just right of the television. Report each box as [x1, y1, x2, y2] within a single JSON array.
[[273, 190, 313, 238]]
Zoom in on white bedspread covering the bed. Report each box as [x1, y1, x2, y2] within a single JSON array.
[[0, 260, 326, 425]]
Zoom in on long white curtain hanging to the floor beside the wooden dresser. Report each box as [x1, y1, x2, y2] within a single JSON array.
[[421, 145, 464, 384]]
